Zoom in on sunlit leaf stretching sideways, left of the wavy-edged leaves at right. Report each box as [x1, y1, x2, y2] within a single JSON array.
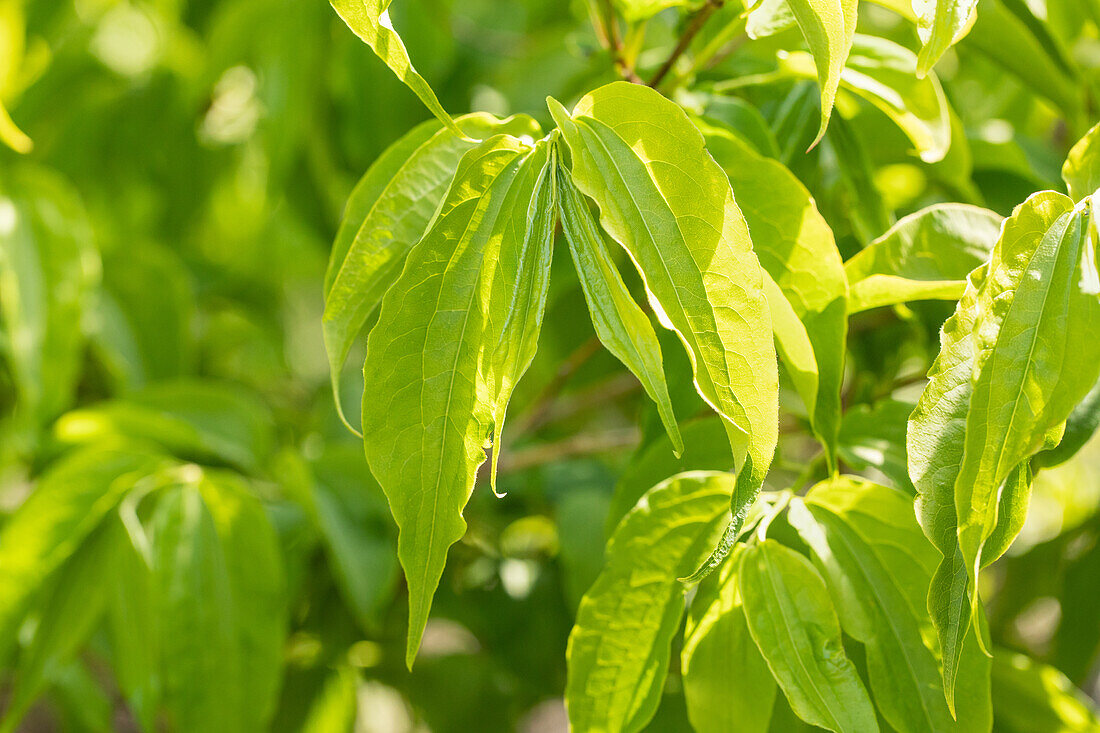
[[844, 204, 1002, 313]]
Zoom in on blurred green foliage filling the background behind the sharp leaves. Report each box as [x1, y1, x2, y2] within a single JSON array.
[[0, 0, 1100, 731]]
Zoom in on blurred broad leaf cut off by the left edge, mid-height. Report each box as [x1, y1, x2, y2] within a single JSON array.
[[0, 166, 99, 429]]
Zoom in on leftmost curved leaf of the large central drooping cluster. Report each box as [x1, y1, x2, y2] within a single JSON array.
[[322, 114, 538, 429]]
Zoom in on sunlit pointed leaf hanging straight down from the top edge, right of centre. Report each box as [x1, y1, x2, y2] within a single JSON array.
[[789, 0, 858, 145]]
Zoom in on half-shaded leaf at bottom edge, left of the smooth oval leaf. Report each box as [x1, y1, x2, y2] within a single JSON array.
[[680, 549, 777, 733]]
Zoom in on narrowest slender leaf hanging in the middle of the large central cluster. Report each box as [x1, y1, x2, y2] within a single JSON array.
[[559, 165, 684, 456]]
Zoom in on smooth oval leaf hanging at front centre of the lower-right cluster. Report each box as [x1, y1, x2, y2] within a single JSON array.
[[739, 539, 879, 733]]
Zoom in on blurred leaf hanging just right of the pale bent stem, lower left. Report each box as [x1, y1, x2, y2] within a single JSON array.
[[151, 482, 244, 732]]
